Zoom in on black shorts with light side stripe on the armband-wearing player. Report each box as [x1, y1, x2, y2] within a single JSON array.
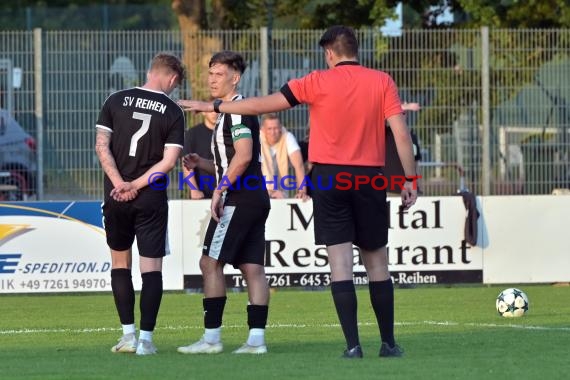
[[202, 203, 269, 268]]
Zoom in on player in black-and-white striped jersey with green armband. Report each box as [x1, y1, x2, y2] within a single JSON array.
[[178, 51, 270, 354]]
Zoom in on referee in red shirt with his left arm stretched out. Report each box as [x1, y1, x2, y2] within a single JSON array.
[[179, 26, 417, 358]]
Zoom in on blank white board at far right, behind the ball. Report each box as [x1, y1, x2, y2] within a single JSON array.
[[480, 195, 570, 284]]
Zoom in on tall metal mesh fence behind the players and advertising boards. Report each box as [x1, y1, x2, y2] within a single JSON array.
[[0, 28, 570, 199]]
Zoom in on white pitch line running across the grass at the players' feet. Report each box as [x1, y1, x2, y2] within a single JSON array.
[[0, 321, 570, 335]]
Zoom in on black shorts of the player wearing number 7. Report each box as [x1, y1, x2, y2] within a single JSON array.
[[102, 189, 168, 258]]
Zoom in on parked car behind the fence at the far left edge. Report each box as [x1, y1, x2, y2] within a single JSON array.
[[0, 109, 37, 200]]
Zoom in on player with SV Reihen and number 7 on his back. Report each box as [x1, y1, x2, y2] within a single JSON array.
[[95, 53, 185, 355]]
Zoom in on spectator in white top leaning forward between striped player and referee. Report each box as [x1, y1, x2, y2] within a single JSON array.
[[260, 113, 308, 199]]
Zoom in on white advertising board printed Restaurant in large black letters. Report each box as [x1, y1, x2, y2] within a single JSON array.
[[182, 196, 483, 288]]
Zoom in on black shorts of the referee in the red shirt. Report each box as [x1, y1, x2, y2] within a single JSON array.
[[311, 164, 388, 250]]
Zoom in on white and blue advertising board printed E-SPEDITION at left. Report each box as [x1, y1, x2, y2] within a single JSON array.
[[0, 202, 183, 293]]
